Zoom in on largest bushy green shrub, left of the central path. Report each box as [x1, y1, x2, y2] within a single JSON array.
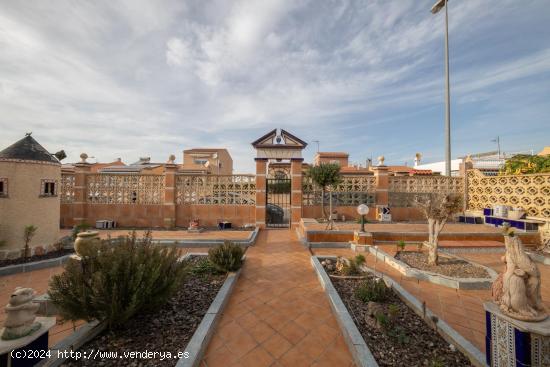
[[48, 232, 187, 328]]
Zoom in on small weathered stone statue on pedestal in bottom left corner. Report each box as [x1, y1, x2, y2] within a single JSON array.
[[2, 287, 41, 340]]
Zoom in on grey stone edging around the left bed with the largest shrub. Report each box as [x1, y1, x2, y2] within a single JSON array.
[[37, 252, 246, 367]]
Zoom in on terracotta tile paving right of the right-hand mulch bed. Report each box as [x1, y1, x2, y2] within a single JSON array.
[[313, 245, 550, 353]]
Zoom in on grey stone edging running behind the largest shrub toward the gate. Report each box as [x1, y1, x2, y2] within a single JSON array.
[[0, 227, 260, 277]]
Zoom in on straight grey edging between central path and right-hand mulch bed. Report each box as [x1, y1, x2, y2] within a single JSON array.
[[311, 256, 378, 367]]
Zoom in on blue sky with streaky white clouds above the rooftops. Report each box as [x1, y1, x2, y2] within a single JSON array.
[[0, 0, 550, 173]]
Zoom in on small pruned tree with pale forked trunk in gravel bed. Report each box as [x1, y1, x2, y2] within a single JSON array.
[[415, 193, 462, 265]]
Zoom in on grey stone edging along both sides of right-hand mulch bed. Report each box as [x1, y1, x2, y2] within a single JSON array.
[[311, 256, 487, 367]]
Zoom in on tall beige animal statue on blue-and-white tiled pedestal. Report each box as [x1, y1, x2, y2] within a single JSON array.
[[493, 227, 547, 321]]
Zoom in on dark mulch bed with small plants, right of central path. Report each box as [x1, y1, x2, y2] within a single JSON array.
[[325, 260, 471, 367]]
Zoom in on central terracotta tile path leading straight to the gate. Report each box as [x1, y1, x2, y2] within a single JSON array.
[[201, 229, 353, 367]]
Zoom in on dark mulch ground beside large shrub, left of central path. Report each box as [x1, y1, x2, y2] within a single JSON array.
[[63, 256, 227, 366]]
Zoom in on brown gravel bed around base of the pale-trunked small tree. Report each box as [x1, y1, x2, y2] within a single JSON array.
[[395, 251, 490, 278]]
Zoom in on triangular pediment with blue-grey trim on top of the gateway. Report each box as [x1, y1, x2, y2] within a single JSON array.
[[252, 129, 307, 159]]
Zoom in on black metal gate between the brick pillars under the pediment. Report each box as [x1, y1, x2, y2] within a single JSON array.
[[265, 178, 291, 228]]
